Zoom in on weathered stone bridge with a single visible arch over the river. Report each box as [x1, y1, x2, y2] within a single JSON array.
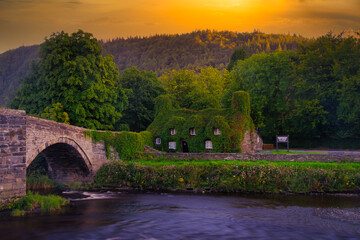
[[0, 108, 108, 204]]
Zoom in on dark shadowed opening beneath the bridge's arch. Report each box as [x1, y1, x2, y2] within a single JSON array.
[[27, 142, 92, 183]]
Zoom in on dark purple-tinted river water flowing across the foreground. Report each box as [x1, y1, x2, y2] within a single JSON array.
[[0, 193, 360, 240]]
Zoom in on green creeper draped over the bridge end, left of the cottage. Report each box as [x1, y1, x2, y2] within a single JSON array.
[[84, 131, 152, 159]]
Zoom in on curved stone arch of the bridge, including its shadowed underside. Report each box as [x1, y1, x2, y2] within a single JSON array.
[[26, 137, 93, 183]]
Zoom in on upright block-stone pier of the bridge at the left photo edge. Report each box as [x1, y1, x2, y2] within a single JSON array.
[[0, 108, 26, 204]]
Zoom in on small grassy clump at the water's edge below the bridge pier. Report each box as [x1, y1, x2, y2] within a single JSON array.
[[2, 191, 69, 216]]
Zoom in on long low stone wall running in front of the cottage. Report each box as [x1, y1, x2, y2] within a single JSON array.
[[143, 152, 360, 162]]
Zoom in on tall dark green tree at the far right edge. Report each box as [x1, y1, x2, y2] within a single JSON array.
[[294, 33, 360, 138]]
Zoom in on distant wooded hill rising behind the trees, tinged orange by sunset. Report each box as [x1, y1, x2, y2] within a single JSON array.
[[0, 30, 309, 106]]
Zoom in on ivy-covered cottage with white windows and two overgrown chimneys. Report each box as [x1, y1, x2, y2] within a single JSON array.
[[148, 91, 263, 153]]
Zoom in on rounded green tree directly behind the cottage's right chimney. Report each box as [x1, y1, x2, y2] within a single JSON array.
[[223, 51, 295, 138]]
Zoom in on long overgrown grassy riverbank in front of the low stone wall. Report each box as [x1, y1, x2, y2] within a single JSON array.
[[95, 160, 360, 193]]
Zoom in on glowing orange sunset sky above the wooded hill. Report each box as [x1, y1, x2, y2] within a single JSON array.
[[0, 0, 360, 53]]
